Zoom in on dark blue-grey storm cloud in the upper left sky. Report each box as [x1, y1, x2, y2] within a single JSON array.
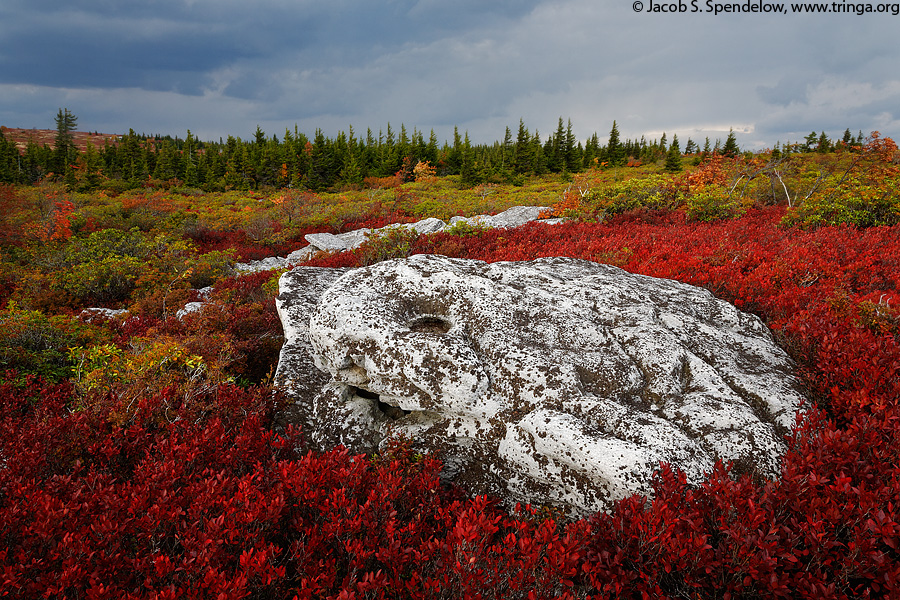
[[0, 0, 534, 91]]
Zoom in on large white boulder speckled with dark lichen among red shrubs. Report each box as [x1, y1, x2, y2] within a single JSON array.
[[278, 255, 802, 514]]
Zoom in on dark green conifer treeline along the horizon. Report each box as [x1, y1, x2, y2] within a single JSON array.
[[0, 115, 861, 191]]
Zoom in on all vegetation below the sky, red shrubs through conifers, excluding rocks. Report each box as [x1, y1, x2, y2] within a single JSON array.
[[0, 111, 900, 599]]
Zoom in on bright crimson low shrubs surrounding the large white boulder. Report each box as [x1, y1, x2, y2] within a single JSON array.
[[0, 208, 900, 599]]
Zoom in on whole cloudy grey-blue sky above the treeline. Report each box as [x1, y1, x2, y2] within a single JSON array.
[[0, 0, 900, 148]]
